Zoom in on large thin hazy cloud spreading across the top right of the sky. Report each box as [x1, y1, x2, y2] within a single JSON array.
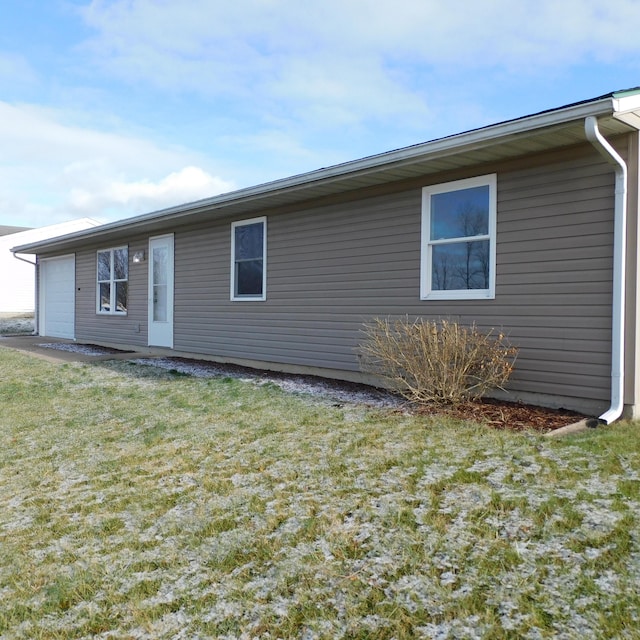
[[72, 0, 640, 158]]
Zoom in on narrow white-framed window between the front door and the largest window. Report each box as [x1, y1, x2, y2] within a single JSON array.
[[231, 218, 267, 300]]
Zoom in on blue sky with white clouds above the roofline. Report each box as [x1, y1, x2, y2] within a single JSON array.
[[0, 0, 640, 227]]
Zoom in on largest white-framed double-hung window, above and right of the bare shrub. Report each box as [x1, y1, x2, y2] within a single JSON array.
[[420, 174, 496, 300]]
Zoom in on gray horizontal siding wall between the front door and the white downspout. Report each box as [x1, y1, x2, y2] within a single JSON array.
[[170, 149, 613, 410]]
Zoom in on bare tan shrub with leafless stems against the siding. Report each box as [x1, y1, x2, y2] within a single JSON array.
[[358, 318, 517, 404]]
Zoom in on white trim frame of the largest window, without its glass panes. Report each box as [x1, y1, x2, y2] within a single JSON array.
[[420, 173, 497, 300]]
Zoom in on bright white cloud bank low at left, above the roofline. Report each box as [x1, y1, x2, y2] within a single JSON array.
[[0, 102, 235, 226]]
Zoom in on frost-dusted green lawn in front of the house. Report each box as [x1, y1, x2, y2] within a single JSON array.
[[0, 349, 640, 640]]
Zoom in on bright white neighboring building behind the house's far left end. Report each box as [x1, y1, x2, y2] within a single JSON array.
[[0, 218, 99, 314]]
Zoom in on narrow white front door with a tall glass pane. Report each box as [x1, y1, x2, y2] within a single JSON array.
[[149, 233, 173, 348]]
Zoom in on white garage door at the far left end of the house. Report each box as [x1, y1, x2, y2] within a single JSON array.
[[38, 255, 76, 338]]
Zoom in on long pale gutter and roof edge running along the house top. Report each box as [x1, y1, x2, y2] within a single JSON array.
[[11, 91, 640, 254]]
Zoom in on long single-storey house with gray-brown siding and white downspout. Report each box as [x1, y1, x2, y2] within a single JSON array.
[[13, 89, 640, 422]]
